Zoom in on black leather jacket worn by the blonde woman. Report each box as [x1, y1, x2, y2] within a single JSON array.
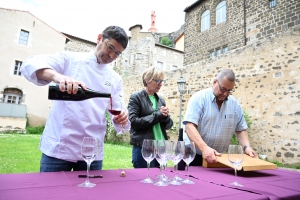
[[128, 90, 173, 147]]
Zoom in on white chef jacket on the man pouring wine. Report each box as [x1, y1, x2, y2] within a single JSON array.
[[21, 52, 130, 162]]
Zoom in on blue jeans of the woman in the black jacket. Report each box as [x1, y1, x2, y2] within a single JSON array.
[[132, 146, 159, 168]]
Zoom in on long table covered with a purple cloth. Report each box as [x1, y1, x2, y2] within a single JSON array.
[[0, 167, 300, 200]]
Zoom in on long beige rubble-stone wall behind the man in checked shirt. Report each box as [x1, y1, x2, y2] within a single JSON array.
[[123, 29, 300, 164]]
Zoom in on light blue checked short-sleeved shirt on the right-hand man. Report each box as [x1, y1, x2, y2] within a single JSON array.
[[183, 88, 248, 154]]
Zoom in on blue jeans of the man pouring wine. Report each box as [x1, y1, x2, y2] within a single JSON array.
[[40, 154, 102, 172]]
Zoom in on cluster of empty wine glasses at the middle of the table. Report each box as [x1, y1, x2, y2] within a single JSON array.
[[141, 139, 196, 186]]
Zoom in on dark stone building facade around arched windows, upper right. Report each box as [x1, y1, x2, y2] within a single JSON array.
[[184, 0, 300, 65]]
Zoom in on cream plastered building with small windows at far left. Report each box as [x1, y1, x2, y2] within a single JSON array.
[[0, 8, 69, 129]]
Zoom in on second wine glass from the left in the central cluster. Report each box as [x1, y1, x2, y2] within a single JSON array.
[[154, 140, 169, 186]]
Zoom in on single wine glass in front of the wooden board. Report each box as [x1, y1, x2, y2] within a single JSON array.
[[228, 145, 244, 187]]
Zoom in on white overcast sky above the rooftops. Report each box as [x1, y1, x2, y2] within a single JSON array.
[[0, 0, 196, 41]]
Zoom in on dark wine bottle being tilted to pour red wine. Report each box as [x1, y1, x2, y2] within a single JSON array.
[[48, 83, 111, 101]]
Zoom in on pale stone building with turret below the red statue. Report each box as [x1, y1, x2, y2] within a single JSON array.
[[113, 25, 183, 76]]
